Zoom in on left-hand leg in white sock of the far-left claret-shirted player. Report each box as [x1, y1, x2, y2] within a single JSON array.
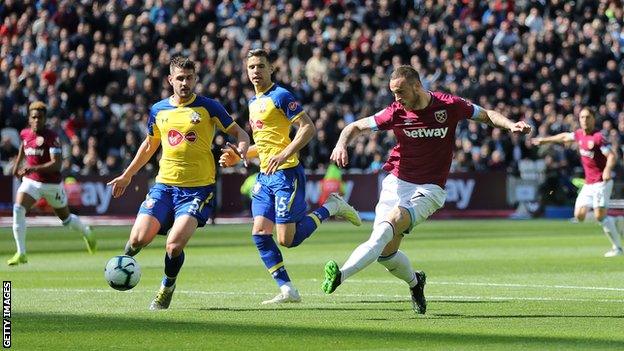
[[7, 182, 41, 266]]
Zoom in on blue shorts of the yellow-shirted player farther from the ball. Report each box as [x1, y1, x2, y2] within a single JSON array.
[[251, 164, 307, 224]]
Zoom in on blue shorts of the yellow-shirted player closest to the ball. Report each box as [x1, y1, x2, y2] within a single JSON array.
[[139, 183, 214, 235]]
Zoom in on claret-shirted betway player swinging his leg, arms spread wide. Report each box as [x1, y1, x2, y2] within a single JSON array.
[[321, 66, 531, 314]]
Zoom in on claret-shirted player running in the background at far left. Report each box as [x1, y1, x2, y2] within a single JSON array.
[[7, 101, 96, 266]]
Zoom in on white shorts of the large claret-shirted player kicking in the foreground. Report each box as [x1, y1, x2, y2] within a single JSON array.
[[374, 174, 446, 234]]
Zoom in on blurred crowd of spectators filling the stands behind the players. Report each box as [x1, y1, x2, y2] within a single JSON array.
[[0, 0, 624, 201]]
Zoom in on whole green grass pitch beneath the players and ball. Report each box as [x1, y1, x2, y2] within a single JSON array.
[[0, 220, 624, 351]]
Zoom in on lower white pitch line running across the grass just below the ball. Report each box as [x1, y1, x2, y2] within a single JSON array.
[[13, 288, 624, 303]]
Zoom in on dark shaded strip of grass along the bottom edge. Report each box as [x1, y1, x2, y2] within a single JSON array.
[[12, 309, 622, 350]]
